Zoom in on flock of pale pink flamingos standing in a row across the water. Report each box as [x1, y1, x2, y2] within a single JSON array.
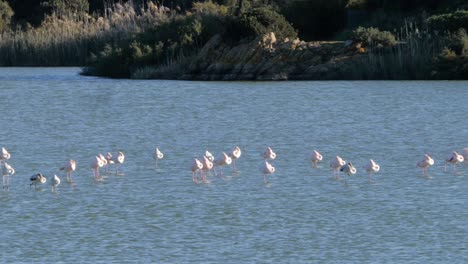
[[0, 146, 468, 191]]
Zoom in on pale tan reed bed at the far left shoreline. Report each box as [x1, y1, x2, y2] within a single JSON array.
[[0, 2, 170, 66]]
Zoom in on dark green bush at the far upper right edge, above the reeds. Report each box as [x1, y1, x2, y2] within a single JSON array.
[[427, 10, 468, 32]]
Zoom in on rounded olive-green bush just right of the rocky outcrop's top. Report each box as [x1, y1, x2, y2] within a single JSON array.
[[352, 27, 397, 47]]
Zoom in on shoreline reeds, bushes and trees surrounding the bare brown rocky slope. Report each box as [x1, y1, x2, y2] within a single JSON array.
[[0, 0, 468, 79]]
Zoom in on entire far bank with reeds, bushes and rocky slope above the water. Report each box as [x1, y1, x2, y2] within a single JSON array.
[[0, 0, 468, 81]]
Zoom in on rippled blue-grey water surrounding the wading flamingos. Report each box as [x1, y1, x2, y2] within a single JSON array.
[[0, 68, 468, 263]]
